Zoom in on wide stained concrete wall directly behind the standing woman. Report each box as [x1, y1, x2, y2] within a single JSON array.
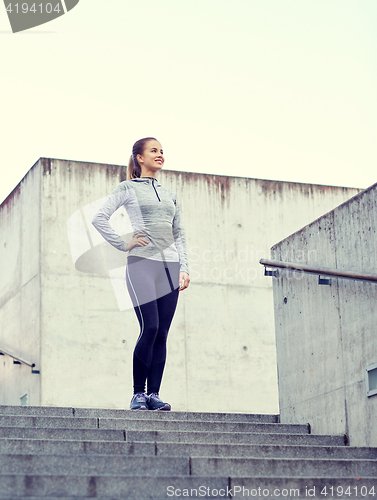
[[0, 159, 359, 413]]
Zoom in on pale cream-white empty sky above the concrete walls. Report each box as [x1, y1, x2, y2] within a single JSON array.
[[0, 0, 377, 202]]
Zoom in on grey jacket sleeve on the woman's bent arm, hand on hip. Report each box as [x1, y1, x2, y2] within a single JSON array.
[[92, 185, 129, 252]]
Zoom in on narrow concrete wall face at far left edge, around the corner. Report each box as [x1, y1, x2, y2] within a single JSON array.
[[0, 165, 41, 405]]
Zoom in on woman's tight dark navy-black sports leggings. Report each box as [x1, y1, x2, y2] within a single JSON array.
[[126, 255, 180, 394]]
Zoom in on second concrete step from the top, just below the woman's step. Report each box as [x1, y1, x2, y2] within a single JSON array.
[[0, 412, 309, 434]]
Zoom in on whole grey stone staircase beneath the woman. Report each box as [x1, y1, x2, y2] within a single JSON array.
[[0, 406, 377, 500]]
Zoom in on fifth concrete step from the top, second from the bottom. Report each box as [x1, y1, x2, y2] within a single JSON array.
[[0, 454, 377, 476]]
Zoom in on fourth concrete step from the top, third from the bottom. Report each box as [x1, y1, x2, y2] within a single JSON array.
[[0, 438, 377, 459]]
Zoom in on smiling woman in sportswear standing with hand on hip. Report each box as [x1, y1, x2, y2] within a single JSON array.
[[92, 137, 190, 411]]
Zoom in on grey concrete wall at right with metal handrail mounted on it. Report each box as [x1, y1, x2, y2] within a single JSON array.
[[271, 184, 377, 446]]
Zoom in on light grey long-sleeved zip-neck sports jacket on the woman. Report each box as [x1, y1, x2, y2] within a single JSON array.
[[92, 177, 189, 273]]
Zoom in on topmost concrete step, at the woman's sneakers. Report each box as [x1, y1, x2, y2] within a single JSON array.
[[0, 405, 279, 424]]
